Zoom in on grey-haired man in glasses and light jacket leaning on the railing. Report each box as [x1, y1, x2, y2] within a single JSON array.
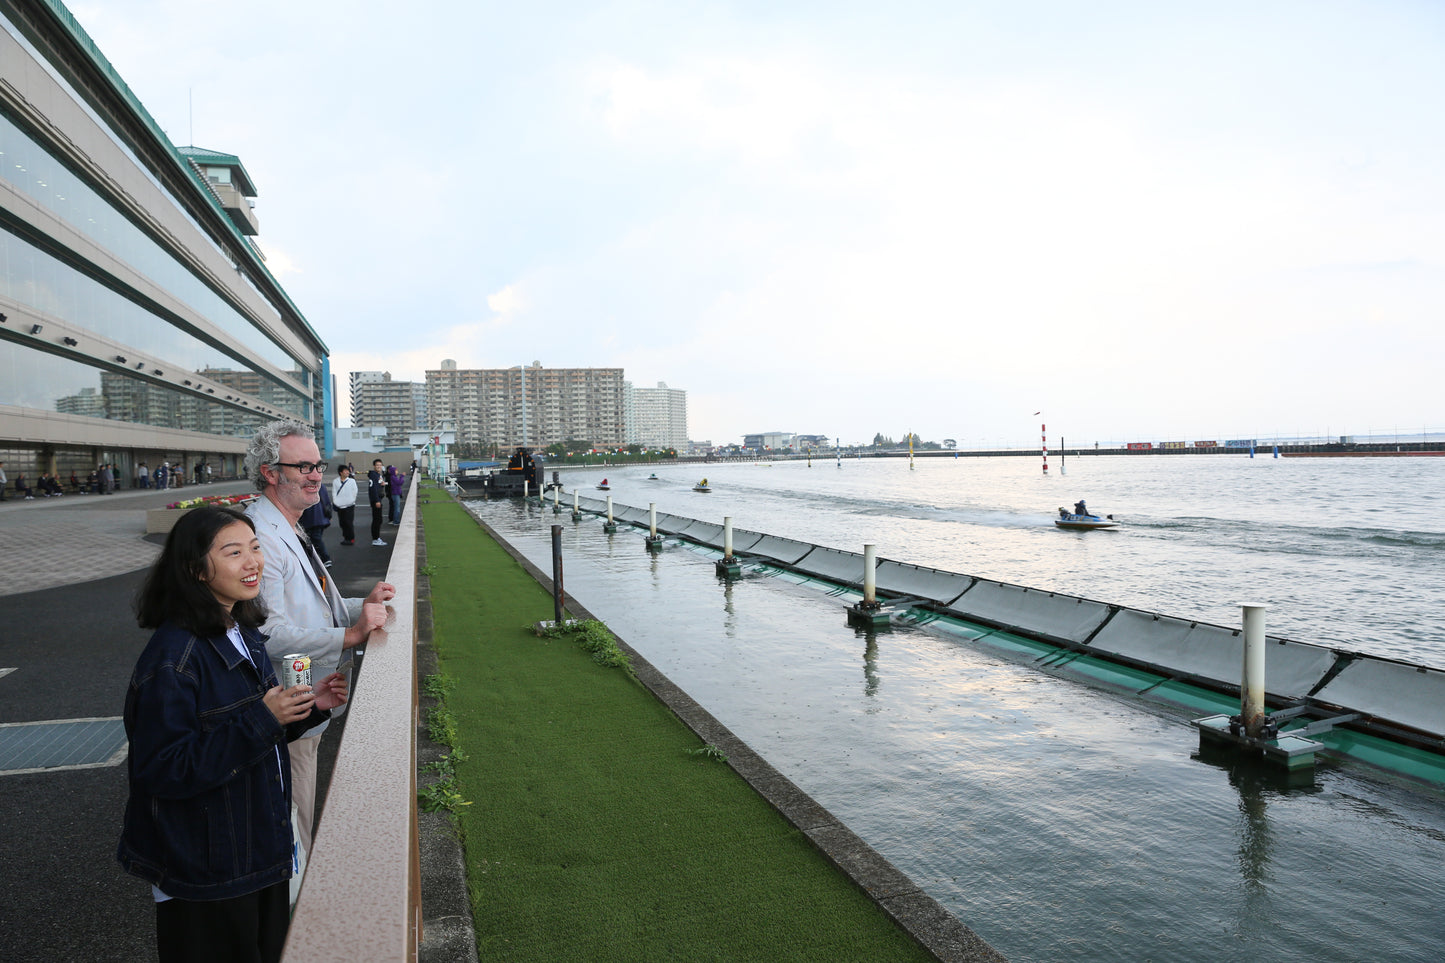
[[246, 421, 396, 853]]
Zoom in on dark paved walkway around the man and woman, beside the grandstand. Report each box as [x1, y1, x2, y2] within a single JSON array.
[[0, 482, 392, 963]]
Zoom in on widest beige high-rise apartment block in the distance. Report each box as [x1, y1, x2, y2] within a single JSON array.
[[426, 359, 624, 448]]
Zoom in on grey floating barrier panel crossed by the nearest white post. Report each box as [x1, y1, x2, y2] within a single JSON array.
[[1090, 609, 1335, 698]]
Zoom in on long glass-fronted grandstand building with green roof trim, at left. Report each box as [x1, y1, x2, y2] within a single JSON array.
[[0, 0, 329, 479]]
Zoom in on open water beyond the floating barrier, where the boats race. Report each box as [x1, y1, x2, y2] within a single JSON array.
[[564, 455, 1445, 668]]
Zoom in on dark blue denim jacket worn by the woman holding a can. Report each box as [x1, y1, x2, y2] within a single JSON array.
[[116, 623, 329, 899]]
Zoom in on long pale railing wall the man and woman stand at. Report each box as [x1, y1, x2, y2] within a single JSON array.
[[282, 473, 422, 963]]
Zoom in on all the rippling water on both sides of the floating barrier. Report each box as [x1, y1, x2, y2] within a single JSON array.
[[474, 457, 1445, 963]]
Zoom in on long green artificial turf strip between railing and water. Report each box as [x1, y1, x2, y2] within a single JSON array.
[[422, 492, 932, 963]]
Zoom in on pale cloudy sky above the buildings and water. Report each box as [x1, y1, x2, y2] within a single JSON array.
[[69, 0, 1445, 447]]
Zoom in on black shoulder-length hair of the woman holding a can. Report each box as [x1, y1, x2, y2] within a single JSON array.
[[136, 505, 266, 636]]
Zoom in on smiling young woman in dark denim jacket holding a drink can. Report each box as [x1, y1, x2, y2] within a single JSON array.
[[117, 506, 347, 963]]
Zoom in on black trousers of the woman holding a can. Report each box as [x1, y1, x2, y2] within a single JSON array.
[[156, 881, 290, 963]]
